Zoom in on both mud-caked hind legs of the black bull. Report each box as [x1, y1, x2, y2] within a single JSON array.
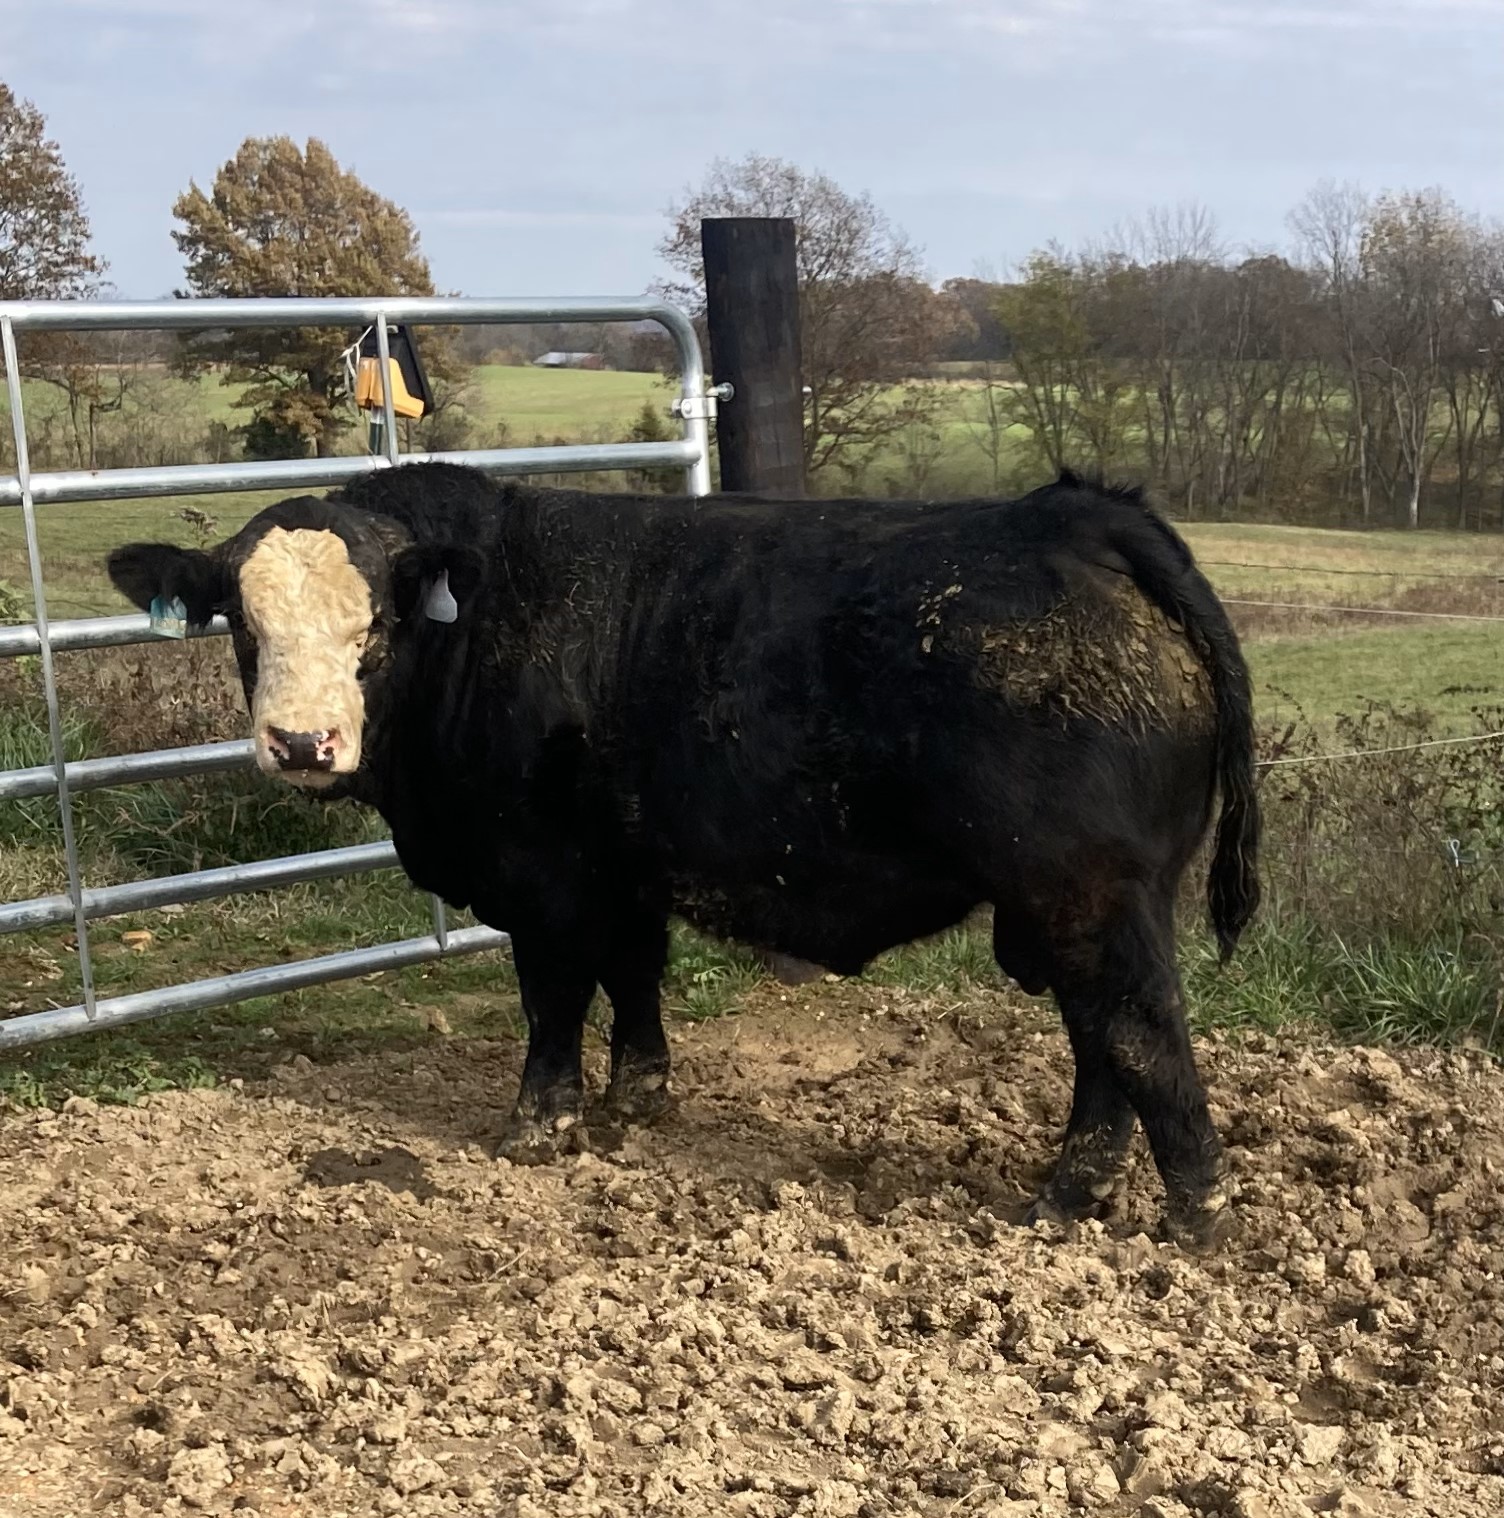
[[1038, 883, 1228, 1246]]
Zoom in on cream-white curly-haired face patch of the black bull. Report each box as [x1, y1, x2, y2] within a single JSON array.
[[234, 527, 373, 789]]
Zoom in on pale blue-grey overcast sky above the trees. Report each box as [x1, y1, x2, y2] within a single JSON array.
[[0, 0, 1504, 298]]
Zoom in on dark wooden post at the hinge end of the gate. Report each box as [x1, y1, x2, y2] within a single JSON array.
[[700, 216, 804, 498]]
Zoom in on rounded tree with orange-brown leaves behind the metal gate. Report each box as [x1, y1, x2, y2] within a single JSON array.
[[173, 137, 458, 457]]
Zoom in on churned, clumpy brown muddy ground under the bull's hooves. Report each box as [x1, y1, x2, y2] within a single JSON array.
[[0, 987, 1504, 1518]]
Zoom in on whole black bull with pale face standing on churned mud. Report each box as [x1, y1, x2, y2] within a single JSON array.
[[109, 465, 1258, 1240]]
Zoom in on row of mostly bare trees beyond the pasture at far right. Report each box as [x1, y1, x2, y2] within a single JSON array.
[[977, 192, 1504, 528]]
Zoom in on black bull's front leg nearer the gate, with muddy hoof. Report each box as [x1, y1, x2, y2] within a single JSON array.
[[498, 932, 596, 1163]]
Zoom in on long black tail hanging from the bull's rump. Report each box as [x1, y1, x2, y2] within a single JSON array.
[[1068, 473, 1260, 961]]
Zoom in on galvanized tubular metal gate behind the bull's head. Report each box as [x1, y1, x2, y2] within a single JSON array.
[[0, 298, 715, 1049]]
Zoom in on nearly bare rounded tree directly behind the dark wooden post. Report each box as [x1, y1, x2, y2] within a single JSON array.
[[659, 153, 956, 477]]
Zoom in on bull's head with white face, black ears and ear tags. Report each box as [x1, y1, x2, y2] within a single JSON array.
[[108, 496, 477, 789]]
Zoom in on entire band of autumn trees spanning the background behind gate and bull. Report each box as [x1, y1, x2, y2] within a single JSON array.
[[0, 83, 1504, 528]]
